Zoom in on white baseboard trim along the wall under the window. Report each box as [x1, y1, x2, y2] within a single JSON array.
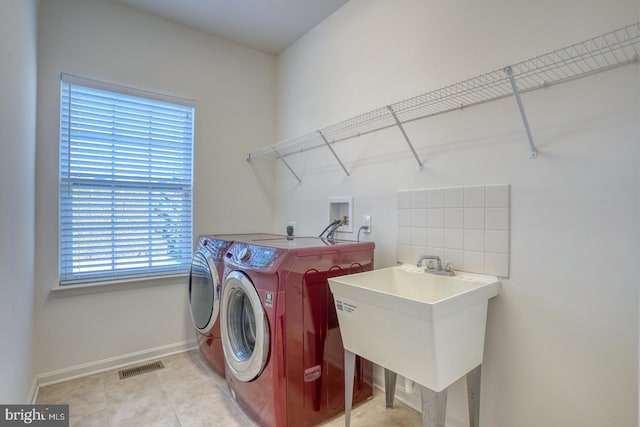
[[31, 340, 198, 402]]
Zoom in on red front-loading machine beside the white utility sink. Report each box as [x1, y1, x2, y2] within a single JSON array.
[[220, 237, 374, 427]]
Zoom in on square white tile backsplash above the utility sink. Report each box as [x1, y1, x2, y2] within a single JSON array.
[[396, 185, 510, 277]]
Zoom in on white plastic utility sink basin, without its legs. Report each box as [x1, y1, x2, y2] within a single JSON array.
[[329, 264, 500, 391]]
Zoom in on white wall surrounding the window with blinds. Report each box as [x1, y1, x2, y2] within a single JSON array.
[[35, 0, 275, 379]]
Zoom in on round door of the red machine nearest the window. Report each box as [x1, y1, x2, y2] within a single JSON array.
[[189, 249, 220, 334]]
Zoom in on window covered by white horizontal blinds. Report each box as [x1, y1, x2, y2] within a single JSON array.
[[59, 74, 194, 285]]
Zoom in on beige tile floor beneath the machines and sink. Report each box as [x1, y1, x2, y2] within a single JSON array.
[[36, 351, 422, 427]]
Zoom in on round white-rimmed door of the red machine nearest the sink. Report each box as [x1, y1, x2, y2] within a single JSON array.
[[220, 271, 269, 381]]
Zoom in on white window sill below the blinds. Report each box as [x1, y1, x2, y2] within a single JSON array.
[[51, 273, 189, 297]]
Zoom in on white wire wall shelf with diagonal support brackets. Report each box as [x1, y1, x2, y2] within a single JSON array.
[[247, 21, 640, 181]]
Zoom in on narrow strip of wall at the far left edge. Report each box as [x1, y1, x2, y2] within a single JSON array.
[[0, 0, 37, 403]]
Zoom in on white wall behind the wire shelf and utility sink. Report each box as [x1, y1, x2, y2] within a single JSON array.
[[275, 0, 640, 427]]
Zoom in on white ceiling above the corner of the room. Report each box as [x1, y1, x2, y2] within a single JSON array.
[[113, 0, 348, 54]]
